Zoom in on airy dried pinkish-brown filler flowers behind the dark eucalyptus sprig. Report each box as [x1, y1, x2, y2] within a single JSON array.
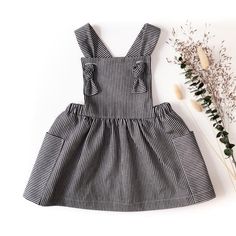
[[167, 22, 236, 123]]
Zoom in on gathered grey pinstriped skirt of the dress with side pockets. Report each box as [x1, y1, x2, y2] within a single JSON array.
[[23, 102, 215, 211]]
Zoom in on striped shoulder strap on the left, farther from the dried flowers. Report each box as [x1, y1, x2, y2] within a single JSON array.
[[74, 23, 112, 58]]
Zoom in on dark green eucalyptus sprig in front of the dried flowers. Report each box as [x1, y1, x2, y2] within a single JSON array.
[[177, 56, 236, 167]]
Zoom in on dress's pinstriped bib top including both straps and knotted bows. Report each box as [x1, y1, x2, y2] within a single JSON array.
[[75, 23, 160, 118]]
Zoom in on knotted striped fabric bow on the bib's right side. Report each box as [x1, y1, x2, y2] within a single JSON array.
[[131, 61, 147, 93]]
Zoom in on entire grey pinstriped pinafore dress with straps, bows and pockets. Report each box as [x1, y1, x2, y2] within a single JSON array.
[[23, 23, 215, 211]]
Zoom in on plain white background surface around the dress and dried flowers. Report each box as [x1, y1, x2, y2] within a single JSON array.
[[0, 0, 236, 236]]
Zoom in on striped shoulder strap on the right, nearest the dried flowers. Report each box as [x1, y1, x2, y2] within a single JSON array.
[[126, 23, 161, 57]]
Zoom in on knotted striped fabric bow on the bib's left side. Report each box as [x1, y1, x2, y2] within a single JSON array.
[[83, 63, 98, 96]]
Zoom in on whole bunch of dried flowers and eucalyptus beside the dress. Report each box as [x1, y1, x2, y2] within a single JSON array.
[[167, 21, 236, 170]]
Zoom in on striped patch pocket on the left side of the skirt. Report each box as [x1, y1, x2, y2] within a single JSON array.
[[23, 132, 65, 204]]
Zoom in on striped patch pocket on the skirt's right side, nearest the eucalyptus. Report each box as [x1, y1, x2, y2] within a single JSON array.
[[172, 131, 215, 198]]
